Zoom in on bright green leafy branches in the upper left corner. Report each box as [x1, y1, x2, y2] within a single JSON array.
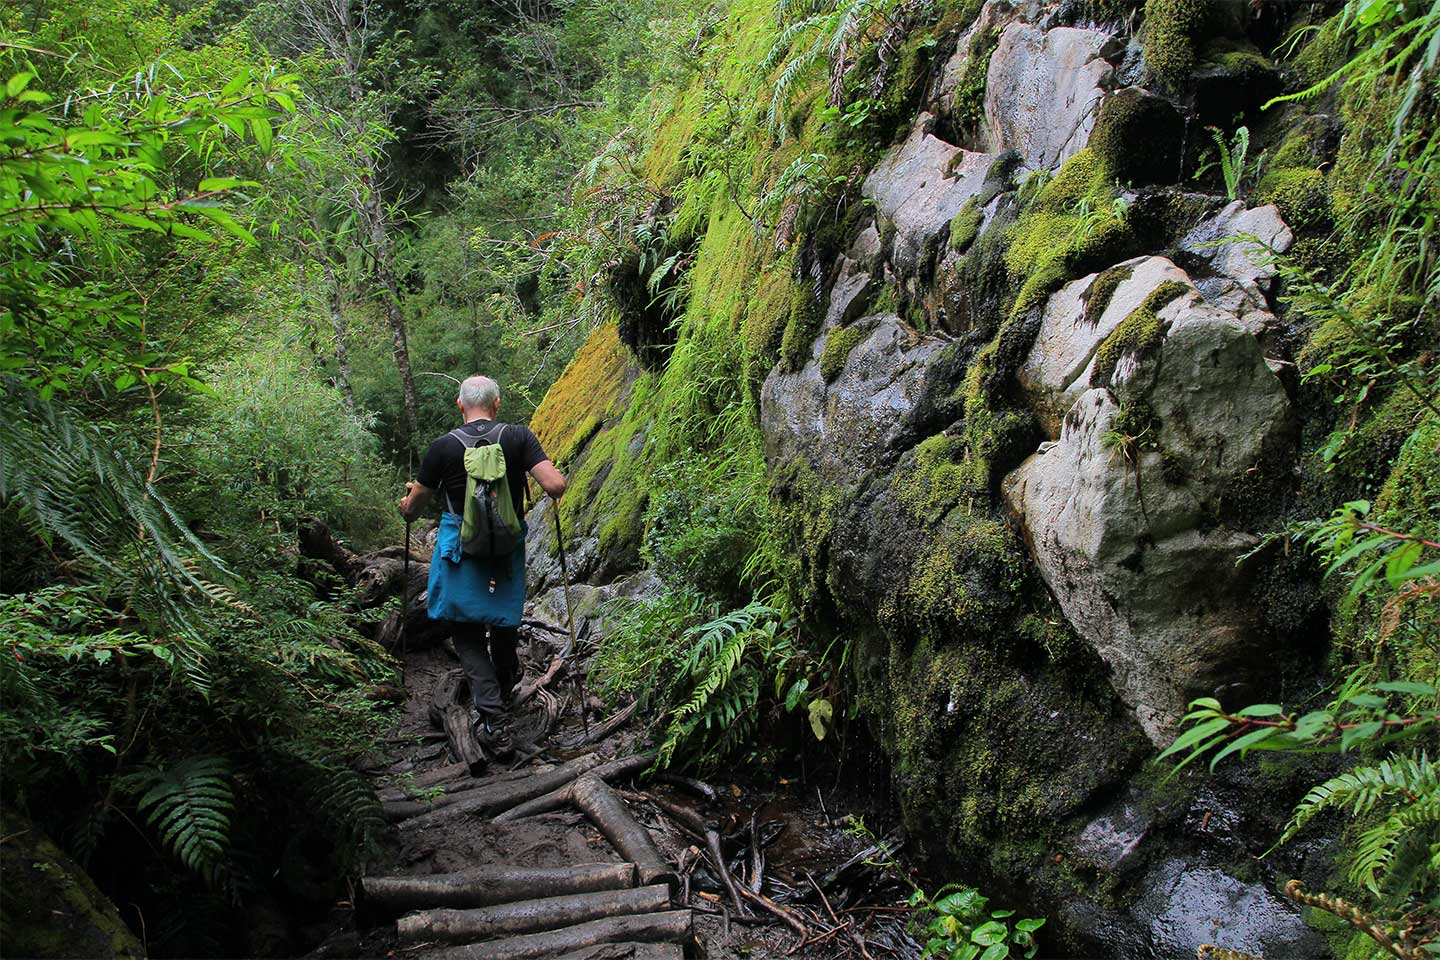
[[0, 39, 298, 399]]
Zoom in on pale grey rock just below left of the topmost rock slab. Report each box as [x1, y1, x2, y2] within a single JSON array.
[[861, 114, 995, 273]]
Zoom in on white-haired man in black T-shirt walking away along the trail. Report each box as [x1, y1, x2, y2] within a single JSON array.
[[400, 377, 566, 759]]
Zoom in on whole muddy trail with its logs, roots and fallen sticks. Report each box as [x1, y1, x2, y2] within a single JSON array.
[[311, 620, 920, 960]]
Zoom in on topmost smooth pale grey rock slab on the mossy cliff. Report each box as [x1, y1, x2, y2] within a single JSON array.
[[985, 23, 1120, 170]]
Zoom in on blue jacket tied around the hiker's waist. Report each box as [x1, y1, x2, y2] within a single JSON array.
[[429, 512, 526, 626]]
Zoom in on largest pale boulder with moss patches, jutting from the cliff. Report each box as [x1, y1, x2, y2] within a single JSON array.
[[1004, 284, 1289, 744]]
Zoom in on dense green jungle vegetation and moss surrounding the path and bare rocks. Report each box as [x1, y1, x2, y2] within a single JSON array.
[[0, 0, 1440, 960]]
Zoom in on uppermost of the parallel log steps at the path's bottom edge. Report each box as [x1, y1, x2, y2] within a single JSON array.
[[356, 864, 635, 920]]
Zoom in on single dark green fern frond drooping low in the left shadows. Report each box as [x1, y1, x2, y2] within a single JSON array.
[[125, 756, 235, 884]]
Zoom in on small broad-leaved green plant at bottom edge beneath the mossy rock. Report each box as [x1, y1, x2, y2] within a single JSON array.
[[909, 884, 1045, 960]]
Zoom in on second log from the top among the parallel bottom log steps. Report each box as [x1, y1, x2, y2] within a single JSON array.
[[395, 884, 670, 943]]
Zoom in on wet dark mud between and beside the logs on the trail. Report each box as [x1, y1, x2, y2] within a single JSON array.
[[311, 618, 920, 960]]
